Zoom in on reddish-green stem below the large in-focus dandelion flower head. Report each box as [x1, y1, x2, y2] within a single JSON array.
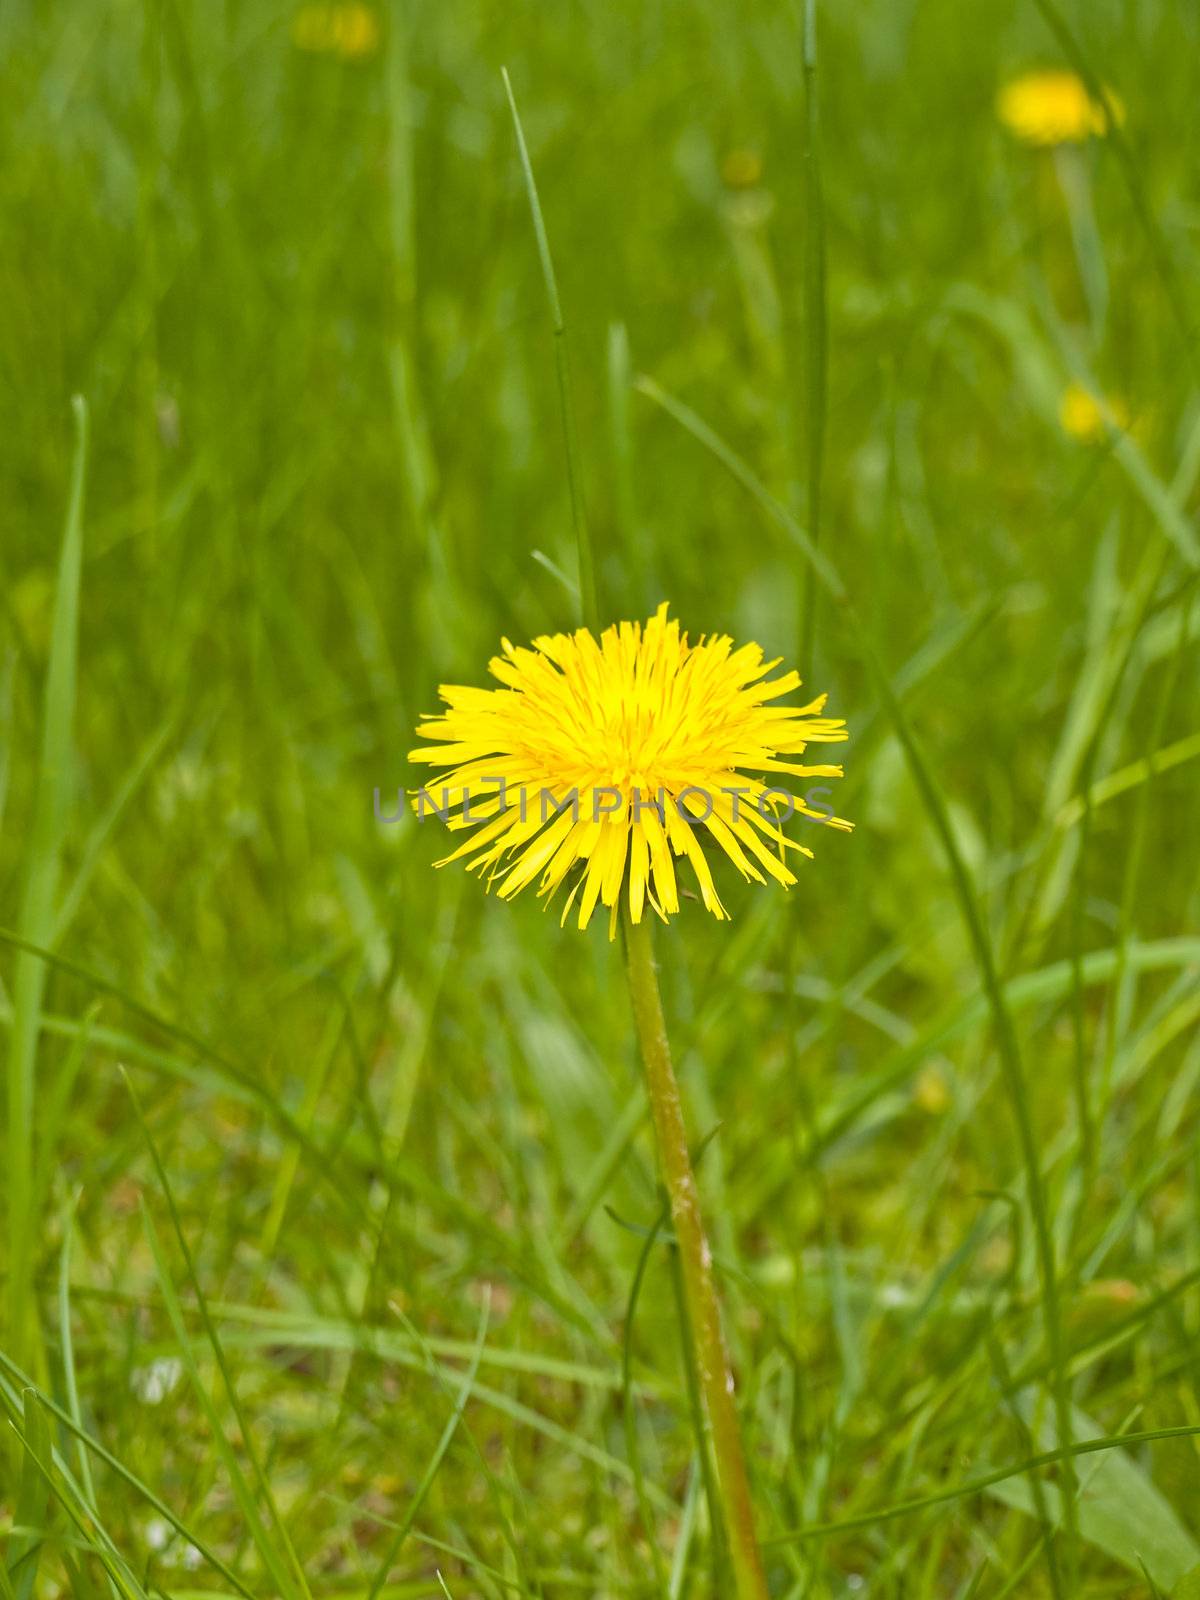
[[626, 914, 766, 1600]]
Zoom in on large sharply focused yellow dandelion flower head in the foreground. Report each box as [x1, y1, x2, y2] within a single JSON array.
[[410, 605, 850, 938]]
